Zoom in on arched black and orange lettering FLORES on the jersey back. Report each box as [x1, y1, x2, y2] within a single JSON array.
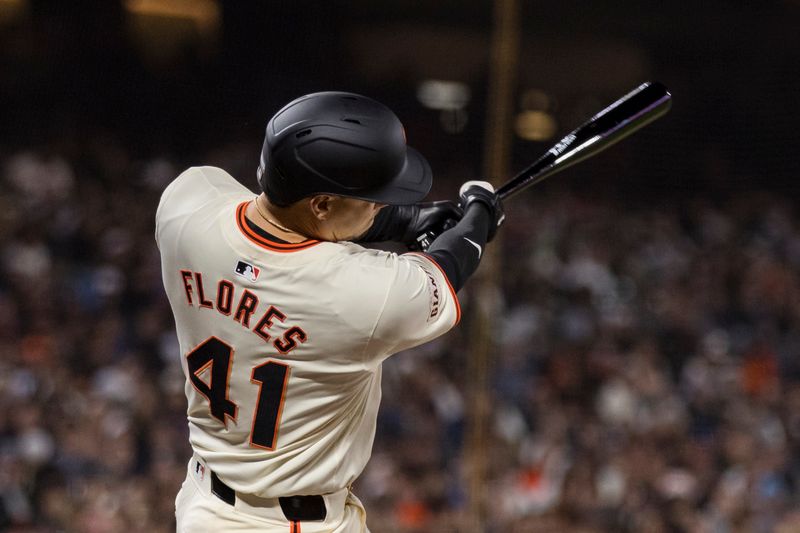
[[179, 270, 308, 354]]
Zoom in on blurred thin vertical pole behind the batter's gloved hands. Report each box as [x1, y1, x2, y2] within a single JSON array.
[[466, 0, 520, 533]]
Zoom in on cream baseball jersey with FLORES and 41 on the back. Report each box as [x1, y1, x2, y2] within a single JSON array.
[[156, 167, 460, 497]]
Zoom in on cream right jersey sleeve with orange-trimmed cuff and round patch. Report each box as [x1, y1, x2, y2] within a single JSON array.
[[366, 253, 461, 364]]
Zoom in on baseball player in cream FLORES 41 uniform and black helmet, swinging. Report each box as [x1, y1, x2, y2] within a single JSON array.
[[156, 92, 503, 533]]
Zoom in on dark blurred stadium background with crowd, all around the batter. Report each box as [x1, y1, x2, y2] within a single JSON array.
[[0, 0, 800, 533]]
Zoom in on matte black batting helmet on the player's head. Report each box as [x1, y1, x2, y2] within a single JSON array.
[[258, 92, 432, 206]]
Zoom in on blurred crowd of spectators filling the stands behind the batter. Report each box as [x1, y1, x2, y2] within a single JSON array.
[[0, 139, 800, 533]]
